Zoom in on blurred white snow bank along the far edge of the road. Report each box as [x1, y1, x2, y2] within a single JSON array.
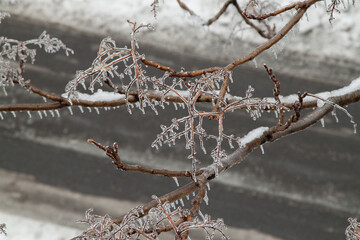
[[0, 0, 360, 66]]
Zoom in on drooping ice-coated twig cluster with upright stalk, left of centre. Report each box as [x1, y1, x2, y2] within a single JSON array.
[[65, 21, 159, 113]]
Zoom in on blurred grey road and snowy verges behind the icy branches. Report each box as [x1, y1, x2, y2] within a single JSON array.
[[0, 0, 360, 240]]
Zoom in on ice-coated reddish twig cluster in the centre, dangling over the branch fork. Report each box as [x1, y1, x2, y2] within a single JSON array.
[[152, 69, 282, 173]]
